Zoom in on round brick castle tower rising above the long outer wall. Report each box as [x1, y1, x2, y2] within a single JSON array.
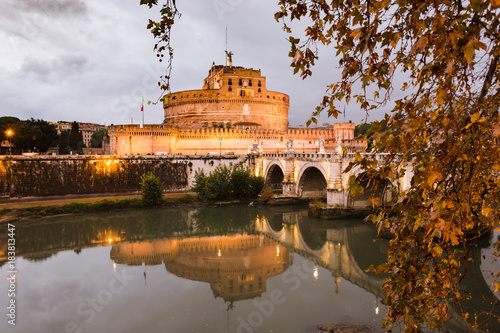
[[163, 65, 290, 130]]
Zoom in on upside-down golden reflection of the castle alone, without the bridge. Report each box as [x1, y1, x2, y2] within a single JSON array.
[[111, 235, 292, 302]]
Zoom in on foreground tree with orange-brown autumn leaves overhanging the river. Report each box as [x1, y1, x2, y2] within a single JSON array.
[[141, 0, 500, 332]]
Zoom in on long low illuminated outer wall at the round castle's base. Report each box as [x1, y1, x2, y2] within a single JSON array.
[[109, 123, 367, 155]]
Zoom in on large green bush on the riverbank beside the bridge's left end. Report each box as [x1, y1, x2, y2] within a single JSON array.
[[192, 166, 264, 201]]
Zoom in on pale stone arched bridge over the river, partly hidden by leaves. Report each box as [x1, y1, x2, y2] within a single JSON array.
[[255, 153, 413, 208]]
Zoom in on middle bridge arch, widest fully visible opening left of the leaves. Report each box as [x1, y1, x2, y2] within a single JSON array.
[[296, 164, 328, 198]]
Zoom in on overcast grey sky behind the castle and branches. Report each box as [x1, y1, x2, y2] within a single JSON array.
[[0, 0, 388, 125]]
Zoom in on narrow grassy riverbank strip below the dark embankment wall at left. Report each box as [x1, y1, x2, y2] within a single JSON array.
[[0, 192, 201, 223]]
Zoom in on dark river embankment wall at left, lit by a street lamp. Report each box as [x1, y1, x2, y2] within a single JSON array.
[[0, 156, 192, 197]]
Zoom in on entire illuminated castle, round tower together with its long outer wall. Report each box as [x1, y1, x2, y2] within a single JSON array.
[[108, 57, 367, 155]]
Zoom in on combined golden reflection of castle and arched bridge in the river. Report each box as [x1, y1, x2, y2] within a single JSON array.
[[104, 209, 385, 302]]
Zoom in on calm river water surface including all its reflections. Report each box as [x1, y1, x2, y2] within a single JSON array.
[[0, 206, 498, 333]]
